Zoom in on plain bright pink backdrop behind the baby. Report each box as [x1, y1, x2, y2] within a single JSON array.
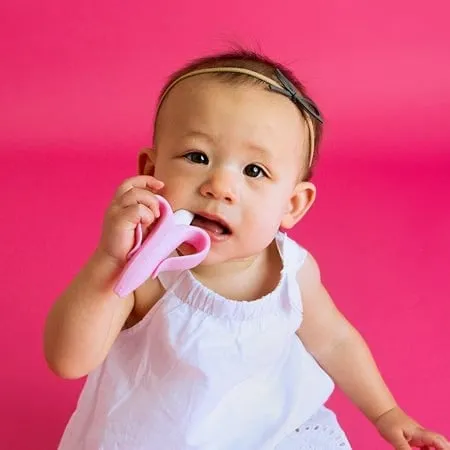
[[0, 0, 450, 450]]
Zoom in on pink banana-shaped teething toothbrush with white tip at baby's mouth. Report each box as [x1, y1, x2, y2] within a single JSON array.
[[114, 195, 210, 297]]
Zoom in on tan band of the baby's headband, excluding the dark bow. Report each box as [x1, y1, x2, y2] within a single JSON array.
[[157, 67, 315, 167]]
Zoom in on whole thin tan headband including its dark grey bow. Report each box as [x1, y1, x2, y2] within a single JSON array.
[[157, 67, 323, 167]]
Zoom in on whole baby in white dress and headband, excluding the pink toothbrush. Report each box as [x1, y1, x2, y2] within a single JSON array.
[[44, 51, 450, 450]]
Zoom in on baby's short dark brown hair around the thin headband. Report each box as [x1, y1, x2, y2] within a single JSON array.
[[155, 50, 323, 180]]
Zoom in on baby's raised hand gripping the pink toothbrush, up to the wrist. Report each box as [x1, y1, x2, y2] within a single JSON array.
[[97, 175, 164, 264]]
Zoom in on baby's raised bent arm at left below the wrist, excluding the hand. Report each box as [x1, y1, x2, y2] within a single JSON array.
[[44, 252, 134, 378]]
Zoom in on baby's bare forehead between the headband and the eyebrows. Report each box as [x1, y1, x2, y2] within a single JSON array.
[[155, 74, 305, 141]]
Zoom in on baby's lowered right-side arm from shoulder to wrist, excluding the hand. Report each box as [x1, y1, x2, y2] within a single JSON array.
[[298, 255, 396, 421]]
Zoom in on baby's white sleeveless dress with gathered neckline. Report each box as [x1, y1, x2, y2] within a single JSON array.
[[59, 233, 350, 450]]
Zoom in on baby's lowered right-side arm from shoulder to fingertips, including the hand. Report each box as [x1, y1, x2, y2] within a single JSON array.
[[297, 251, 450, 450]]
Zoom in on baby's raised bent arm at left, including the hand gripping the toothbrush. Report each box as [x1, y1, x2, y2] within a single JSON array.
[[44, 176, 163, 378]]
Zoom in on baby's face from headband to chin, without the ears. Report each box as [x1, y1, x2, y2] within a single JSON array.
[[144, 76, 312, 264]]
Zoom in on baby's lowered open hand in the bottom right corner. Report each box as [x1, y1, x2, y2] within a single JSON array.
[[375, 408, 450, 450]]
